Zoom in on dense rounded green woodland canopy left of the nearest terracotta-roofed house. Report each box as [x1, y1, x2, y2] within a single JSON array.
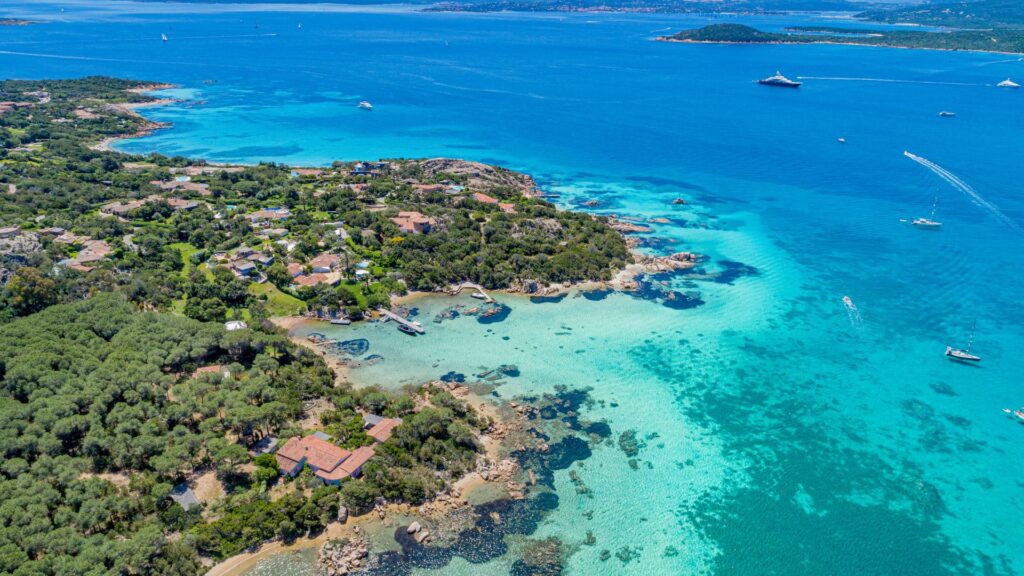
[[0, 294, 332, 575]]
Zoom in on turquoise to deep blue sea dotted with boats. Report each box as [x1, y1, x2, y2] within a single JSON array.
[[0, 0, 1024, 576]]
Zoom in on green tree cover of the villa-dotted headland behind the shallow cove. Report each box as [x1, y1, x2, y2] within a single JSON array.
[[0, 78, 629, 323]]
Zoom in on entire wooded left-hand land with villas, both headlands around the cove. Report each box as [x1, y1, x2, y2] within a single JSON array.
[[0, 77, 631, 576]]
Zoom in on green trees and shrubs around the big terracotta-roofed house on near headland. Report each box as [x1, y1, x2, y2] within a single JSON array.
[[0, 293, 489, 575]]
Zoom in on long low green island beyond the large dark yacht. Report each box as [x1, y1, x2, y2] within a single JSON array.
[[657, 24, 1024, 54]]
